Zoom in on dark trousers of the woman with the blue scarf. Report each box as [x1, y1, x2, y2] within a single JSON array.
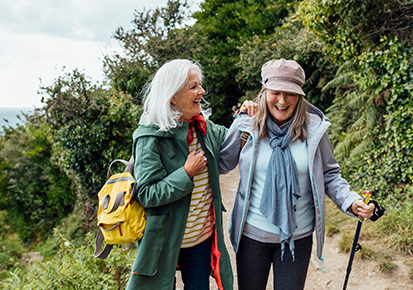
[[237, 235, 313, 290]]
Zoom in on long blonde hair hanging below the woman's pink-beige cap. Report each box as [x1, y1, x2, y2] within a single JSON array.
[[252, 88, 309, 142]]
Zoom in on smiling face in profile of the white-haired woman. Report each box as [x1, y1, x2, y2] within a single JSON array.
[[171, 69, 205, 120]]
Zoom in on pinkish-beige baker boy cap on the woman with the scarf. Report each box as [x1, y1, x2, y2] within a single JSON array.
[[261, 59, 305, 96]]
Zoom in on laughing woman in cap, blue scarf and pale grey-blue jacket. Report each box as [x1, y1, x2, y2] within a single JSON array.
[[220, 59, 374, 290]]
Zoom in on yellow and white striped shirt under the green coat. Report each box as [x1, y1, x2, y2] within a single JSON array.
[[181, 130, 213, 248]]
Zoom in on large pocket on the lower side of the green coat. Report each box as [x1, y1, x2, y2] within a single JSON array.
[[132, 206, 169, 276]]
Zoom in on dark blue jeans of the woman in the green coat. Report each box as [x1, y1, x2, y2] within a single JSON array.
[[174, 238, 211, 290]]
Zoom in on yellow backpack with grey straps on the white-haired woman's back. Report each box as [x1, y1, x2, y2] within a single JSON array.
[[94, 157, 146, 259]]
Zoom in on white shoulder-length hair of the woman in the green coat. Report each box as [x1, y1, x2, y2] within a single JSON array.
[[143, 59, 210, 131]]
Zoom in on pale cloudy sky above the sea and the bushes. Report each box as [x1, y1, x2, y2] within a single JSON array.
[[0, 0, 201, 108]]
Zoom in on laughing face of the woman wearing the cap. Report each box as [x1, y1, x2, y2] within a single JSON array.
[[265, 90, 299, 127]]
